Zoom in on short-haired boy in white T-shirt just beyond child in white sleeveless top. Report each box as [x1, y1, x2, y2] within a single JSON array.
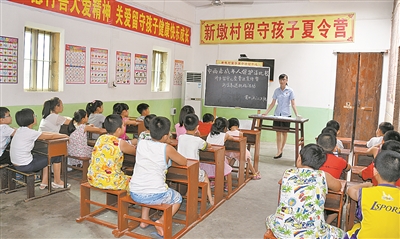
[[178, 114, 214, 205]]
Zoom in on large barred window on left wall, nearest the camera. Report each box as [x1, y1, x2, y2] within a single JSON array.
[[24, 27, 60, 91]]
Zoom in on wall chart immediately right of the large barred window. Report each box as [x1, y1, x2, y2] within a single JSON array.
[[65, 45, 86, 84]]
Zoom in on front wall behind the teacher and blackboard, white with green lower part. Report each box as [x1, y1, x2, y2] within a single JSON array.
[[193, 1, 393, 143]]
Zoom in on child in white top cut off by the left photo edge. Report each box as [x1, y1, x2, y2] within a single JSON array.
[[0, 107, 15, 164]]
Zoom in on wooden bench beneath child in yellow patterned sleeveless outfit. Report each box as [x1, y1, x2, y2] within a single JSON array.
[[76, 182, 126, 229]]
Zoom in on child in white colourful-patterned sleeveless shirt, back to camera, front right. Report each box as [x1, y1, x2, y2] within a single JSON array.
[[266, 144, 344, 239]]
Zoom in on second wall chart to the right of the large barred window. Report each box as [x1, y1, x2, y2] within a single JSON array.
[[90, 48, 108, 84]]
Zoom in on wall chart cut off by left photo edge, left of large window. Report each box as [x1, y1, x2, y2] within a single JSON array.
[[0, 36, 18, 83]]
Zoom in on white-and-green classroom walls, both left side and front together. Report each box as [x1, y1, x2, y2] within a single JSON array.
[[0, 0, 397, 143]]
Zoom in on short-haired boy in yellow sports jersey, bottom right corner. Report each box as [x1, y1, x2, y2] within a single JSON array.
[[344, 150, 400, 239]]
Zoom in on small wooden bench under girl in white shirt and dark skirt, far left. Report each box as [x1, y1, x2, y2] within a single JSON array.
[[5, 166, 37, 202]]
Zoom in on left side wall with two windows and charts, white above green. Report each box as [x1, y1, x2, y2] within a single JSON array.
[[0, 1, 195, 106]]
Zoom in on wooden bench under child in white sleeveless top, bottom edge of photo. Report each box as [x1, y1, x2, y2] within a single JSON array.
[[113, 195, 173, 238]]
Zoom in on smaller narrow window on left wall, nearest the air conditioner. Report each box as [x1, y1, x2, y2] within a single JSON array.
[[151, 50, 169, 92]]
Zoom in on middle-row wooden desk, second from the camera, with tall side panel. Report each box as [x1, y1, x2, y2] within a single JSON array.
[[199, 145, 225, 205]]
